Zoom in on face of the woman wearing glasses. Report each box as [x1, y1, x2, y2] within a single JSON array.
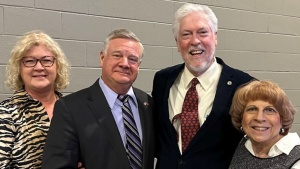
[[20, 45, 56, 93]]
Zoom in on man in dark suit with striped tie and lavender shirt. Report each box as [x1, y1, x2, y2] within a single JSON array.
[[42, 29, 154, 169]]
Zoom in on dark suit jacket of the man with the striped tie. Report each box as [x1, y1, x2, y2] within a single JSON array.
[[42, 80, 154, 169]]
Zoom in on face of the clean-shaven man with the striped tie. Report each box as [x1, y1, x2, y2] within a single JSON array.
[[100, 38, 142, 94]]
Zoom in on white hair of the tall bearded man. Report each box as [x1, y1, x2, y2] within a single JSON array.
[[173, 3, 218, 39]]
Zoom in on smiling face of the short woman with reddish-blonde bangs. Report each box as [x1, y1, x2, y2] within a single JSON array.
[[242, 100, 282, 146]]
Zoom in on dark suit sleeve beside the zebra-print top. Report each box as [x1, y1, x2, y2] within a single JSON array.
[[42, 99, 80, 169]]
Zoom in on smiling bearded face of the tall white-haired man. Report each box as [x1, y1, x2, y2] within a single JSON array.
[[176, 12, 217, 77]]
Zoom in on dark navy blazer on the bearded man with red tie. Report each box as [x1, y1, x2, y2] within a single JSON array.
[[152, 58, 253, 169]]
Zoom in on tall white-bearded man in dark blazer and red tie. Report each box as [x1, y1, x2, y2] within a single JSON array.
[[152, 4, 253, 169]]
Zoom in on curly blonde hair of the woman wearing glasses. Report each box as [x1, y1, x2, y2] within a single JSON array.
[[5, 30, 70, 90]]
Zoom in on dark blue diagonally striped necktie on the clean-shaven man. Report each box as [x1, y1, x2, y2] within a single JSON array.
[[118, 95, 143, 169]]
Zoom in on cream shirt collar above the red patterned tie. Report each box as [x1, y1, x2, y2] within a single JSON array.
[[182, 58, 218, 90]]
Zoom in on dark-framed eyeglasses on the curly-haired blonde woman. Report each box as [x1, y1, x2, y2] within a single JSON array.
[[22, 56, 55, 67]]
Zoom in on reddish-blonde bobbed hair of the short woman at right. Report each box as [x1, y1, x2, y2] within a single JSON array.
[[230, 81, 296, 135]]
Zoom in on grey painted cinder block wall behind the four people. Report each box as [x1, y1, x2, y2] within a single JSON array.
[[0, 0, 300, 134]]
